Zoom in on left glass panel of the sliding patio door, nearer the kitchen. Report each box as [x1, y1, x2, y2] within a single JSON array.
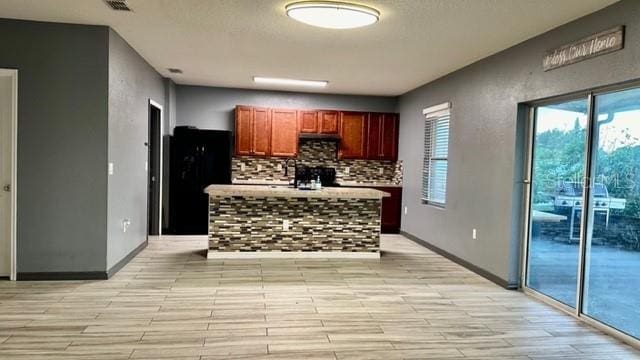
[[526, 98, 588, 308]]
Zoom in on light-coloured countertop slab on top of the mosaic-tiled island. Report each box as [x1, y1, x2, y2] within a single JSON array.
[[204, 185, 390, 199]]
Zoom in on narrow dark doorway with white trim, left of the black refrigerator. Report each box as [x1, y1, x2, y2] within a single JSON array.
[[147, 100, 162, 235]]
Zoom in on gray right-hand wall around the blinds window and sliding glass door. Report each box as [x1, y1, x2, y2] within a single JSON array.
[[398, 0, 640, 283]]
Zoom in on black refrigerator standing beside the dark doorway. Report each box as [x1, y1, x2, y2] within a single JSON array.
[[169, 126, 232, 235]]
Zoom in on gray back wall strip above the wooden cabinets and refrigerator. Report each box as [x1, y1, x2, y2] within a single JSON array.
[[176, 85, 396, 130]]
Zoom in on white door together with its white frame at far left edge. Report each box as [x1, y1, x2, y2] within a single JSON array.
[[0, 69, 18, 280]]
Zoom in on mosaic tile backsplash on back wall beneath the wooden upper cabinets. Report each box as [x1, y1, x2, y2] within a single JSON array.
[[231, 139, 402, 185]]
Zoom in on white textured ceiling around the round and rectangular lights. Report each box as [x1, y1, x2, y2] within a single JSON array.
[[0, 0, 617, 95]]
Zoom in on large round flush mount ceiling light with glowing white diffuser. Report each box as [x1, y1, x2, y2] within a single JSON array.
[[285, 1, 380, 29]]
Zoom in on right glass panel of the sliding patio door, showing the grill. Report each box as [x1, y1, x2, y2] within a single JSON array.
[[582, 89, 640, 338]]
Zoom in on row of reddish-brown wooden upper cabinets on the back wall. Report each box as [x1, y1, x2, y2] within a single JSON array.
[[235, 106, 400, 161]]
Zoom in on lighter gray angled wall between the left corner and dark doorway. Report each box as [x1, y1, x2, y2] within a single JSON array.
[[107, 30, 165, 269]]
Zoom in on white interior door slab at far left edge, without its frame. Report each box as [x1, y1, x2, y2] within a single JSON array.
[[0, 73, 13, 277]]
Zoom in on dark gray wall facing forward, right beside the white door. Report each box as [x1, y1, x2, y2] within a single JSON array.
[[0, 19, 108, 273]]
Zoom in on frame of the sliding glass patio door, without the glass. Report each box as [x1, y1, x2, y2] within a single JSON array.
[[520, 80, 640, 349]]
